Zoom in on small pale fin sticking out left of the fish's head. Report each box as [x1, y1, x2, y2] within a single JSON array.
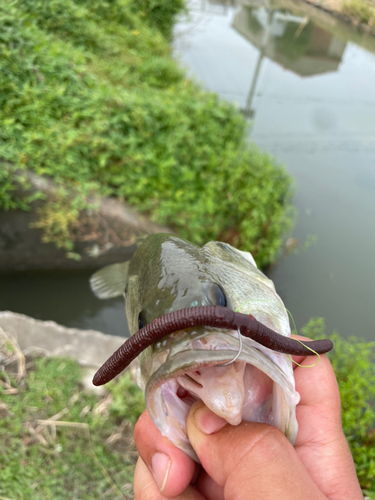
[[90, 262, 129, 299]]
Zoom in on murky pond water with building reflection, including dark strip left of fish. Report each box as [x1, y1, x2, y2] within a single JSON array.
[[0, 0, 375, 340]]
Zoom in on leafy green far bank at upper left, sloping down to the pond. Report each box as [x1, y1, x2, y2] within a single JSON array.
[[0, 0, 291, 265]]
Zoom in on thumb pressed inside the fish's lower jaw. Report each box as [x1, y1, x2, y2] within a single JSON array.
[[186, 401, 327, 500]]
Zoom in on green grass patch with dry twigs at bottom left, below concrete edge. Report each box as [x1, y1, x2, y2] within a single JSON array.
[[0, 358, 143, 500]]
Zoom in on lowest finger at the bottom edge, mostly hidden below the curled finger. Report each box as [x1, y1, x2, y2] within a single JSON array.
[[134, 458, 206, 500]]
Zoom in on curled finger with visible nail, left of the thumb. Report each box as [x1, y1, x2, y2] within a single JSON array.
[[134, 410, 201, 498]]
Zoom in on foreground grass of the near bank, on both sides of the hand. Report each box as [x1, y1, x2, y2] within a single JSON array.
[[0, 319, 375, 500]]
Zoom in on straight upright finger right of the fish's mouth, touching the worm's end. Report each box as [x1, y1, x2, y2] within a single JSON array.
[[294, 355, 363, 500]]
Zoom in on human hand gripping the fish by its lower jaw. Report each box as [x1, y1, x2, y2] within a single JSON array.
[[134, 336, 363, 500]]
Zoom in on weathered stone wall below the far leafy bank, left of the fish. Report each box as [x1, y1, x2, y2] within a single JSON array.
[[0, 173, 172, 273]]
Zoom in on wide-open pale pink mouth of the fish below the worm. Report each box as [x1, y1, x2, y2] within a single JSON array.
[[145, 331, 299, 461]]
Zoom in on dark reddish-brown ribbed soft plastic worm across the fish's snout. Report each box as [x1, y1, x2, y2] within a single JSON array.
[[93, 306, 333, 385]]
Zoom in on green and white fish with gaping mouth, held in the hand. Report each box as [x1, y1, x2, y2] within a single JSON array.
[[90, 233, 299, 461]]
